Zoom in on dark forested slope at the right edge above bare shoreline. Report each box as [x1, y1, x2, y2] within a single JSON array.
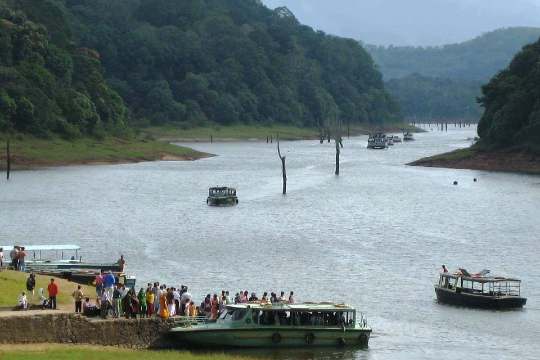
[[478, 40, 540, 153]]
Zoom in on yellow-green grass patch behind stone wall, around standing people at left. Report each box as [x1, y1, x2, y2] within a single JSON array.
[[0, 270, 96, 306]]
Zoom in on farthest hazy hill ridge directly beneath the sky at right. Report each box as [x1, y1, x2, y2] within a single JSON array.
[[366, 27, 540, 81]]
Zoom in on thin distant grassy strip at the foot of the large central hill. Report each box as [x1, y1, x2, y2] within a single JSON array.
[[142, 124, 418, 142]]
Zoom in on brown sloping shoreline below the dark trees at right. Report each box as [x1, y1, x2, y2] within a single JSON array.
[[407, 147, 540, 175]]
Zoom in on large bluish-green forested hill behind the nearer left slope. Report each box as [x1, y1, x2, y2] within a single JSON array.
[[47, 0, 399, 126]]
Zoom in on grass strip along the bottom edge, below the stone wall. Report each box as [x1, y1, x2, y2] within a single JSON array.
[[0, 344, 251, 360]]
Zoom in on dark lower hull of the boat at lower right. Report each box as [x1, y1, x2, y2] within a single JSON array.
[[435, 286, 527, 310]]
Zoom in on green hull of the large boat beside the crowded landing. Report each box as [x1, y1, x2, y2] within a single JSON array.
[[171, 327, 371, 348]]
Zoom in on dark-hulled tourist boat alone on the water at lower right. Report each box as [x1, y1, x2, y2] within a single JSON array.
[[435, 269, 527, 310]]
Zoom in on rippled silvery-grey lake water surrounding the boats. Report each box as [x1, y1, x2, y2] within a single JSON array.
[[0, 128, 540, 359]]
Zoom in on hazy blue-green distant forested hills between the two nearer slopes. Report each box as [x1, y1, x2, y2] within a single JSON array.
[[366, 27, 540, 121]]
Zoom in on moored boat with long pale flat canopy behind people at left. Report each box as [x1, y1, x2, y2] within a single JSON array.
[[3, 245, 124, 284]]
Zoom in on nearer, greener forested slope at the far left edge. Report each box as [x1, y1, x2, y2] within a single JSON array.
[[0, 0, 127, 138]]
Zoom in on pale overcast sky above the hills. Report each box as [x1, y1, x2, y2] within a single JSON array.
[[263, 0, 540, 45]]
